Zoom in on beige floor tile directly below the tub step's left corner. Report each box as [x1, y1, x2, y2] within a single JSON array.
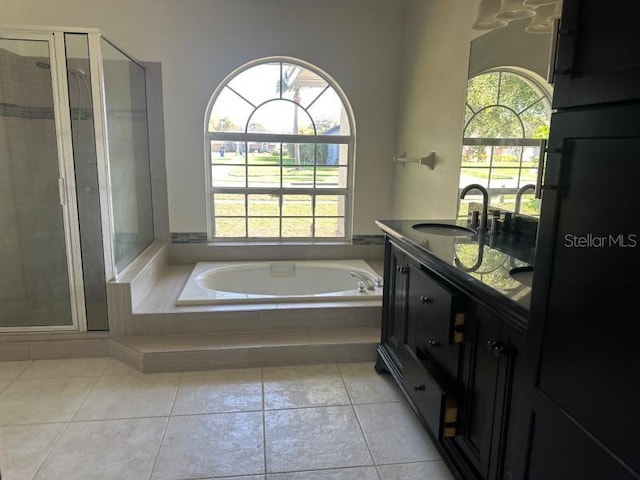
[[74, 373, 181, 421]]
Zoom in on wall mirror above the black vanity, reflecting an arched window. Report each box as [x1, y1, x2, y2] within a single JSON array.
[[458, 13, 554, 227]]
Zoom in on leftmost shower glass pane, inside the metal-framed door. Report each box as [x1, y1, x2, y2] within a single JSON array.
[[0, 38, 73, 327]]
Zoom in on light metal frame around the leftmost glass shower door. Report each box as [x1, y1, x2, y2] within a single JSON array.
[[0, 27, 87, 333]]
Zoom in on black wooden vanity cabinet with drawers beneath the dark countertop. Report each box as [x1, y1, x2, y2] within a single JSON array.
[[377, 238, 523, 480]]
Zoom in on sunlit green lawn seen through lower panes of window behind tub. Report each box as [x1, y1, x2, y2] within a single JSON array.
[[212, 152, 347, 238]]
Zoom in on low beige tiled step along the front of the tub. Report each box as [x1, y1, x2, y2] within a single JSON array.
[[111, 327, 380, 372]]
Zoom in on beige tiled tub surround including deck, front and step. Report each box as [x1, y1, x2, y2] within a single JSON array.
[[104, 260, 383, 373]]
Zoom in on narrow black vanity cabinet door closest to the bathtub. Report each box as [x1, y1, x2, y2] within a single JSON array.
[[382, 241, 409, 370]]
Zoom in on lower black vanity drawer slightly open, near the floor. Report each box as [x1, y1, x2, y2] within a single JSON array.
[[402, 347, 458, 438]]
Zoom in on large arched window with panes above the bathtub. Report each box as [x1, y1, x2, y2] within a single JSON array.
[[205, 58, 354, 241]]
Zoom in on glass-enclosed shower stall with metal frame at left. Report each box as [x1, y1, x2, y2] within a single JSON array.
[[0, 27, 154, 333]]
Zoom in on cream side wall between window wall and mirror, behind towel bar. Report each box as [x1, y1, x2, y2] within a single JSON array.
[[392, 0, 477, 219]]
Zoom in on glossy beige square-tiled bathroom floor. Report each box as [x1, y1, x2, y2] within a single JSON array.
[[0, 358, 453, 480]]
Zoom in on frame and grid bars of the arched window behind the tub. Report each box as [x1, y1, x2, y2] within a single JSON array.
[[204, 56, 355, 244]]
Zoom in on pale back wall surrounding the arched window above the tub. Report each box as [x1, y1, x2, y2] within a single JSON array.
[[2, 0, 404, 234]]
